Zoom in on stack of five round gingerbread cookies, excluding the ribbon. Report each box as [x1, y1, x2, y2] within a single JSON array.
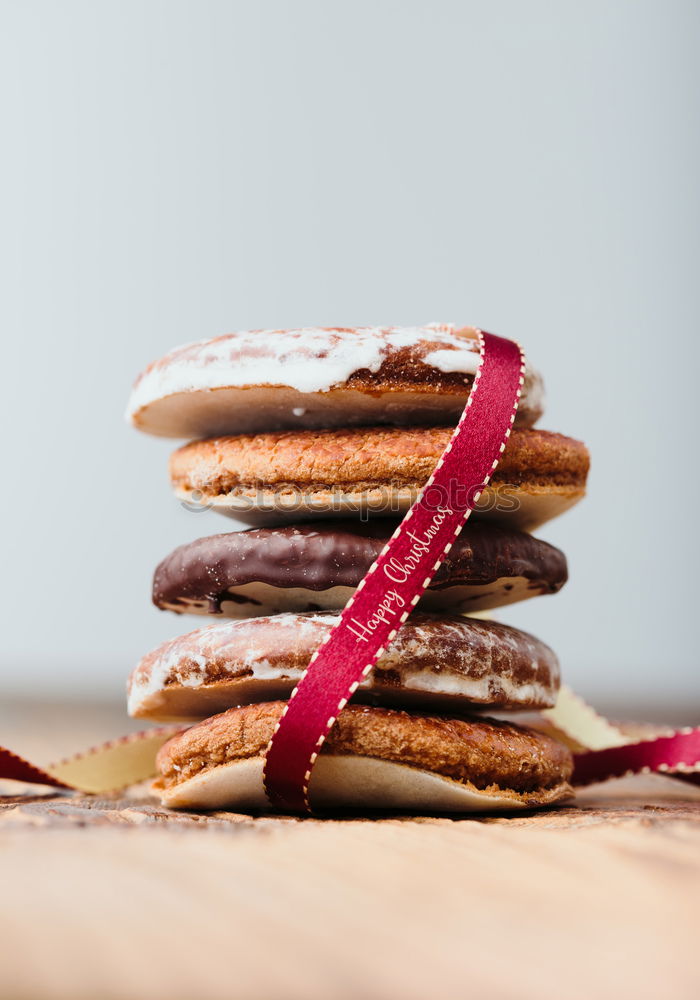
[[128, 324, 588, 812]]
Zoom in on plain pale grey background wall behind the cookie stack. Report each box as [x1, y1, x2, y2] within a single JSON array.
[[0, 0, 700, 721]]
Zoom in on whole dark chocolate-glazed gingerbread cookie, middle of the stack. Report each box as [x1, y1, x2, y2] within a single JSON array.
[[153, 519, 567, 618]]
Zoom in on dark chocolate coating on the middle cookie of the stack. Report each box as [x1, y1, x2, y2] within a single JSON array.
[[153, 520, 567, 614]]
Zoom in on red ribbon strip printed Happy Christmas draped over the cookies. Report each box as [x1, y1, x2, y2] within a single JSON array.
[[265, 333, 524, 812]]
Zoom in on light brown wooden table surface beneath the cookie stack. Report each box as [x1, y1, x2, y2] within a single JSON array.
[[0, 712, 700, 1000]]
